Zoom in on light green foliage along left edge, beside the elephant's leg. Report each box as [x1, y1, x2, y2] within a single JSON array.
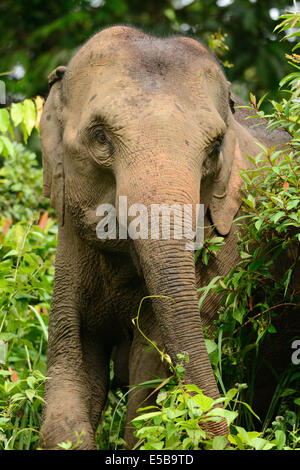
[[0, 99, 57, 450]]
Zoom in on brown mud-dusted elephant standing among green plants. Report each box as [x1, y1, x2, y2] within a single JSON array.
[[40, 26, 287, 449]]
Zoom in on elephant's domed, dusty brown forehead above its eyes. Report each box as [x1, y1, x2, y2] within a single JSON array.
[[64, 27, 227, 129]]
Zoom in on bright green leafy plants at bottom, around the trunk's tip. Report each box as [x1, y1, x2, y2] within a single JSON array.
[[132, 346, 299, 450]]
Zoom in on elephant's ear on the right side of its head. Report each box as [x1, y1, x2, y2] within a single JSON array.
[[209, 118, 259, 236]]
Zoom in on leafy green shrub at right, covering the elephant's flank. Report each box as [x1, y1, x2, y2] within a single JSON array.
[[199, 8, 300, 444]]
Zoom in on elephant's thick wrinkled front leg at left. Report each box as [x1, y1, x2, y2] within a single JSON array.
[[40, 221, 110, 449]]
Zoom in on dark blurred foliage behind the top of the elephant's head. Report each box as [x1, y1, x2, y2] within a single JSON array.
[[0, 0, 291, 101]]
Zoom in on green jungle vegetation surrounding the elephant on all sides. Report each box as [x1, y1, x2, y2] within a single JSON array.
[[0, 0, 300, 450]]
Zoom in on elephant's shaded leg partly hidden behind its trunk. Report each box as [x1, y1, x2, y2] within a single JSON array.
[[124, 301, 171, 448]]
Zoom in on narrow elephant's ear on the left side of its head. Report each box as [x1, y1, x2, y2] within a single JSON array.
[[40, 67, 66, 225]]
